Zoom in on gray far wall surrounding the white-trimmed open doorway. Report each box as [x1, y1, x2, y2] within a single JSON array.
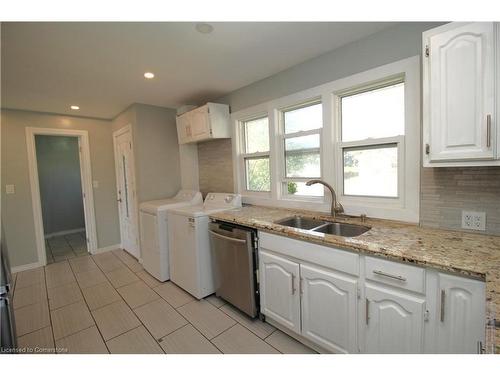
[[1, 109, 120, 267]]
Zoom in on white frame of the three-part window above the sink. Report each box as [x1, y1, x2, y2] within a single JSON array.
[[231, 56, 421, 223]]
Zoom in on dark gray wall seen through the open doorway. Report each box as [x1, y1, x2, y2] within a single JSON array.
[[35, 135, 85, 234]]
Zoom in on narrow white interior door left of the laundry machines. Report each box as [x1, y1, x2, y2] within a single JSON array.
[[113, 128, 140, 258]]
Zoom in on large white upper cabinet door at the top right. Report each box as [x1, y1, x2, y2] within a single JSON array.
[[424, 22, 495, 162]]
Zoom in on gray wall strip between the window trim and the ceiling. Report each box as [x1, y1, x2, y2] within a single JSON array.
[[216, 22, 442, 112]]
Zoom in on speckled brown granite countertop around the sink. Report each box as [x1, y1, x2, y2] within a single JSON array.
[[210, 206, 500, 353]]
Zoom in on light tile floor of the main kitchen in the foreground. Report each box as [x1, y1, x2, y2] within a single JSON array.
[[14, 250, 314, 354]]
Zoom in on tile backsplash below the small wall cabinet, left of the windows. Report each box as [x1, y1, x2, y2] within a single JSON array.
[[198, 139, 234, 196]]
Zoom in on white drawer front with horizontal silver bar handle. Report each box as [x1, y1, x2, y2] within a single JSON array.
[[365, 257, 425, 293]]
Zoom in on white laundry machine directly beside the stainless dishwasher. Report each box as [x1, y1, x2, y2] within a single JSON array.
[[168, 193, 241, 299]]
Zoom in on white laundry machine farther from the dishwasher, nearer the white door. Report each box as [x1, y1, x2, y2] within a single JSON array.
[[139, 190, 203, 281]]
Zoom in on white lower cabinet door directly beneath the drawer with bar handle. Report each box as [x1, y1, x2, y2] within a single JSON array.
[[365, 285, 425, 354]]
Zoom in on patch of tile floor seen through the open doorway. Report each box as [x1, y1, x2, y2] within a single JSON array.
[[45, 232, 88, 264]]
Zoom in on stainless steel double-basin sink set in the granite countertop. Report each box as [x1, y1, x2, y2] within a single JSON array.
[[274, 216, 370, 237]]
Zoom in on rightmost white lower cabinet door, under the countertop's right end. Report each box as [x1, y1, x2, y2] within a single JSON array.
[[437, 274, 486, 354]]
